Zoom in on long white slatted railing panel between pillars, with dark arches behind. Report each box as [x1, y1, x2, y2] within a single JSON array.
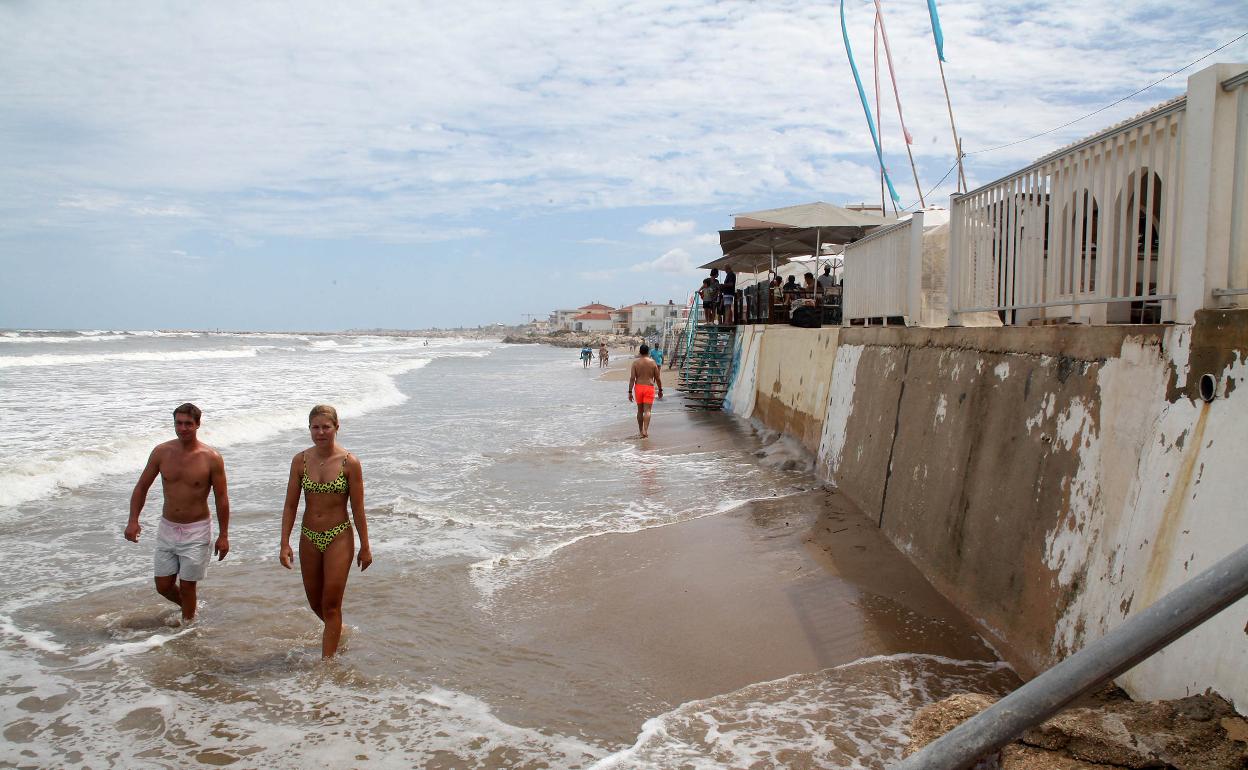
[[950, 97, 1187, 323]]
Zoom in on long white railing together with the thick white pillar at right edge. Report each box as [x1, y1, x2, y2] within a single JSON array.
[[948, 64, 1248, 326]]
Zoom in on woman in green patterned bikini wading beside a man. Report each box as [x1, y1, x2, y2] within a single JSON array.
[[280, 404, 373, 658]]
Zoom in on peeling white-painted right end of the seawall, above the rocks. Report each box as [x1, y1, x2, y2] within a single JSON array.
[[1045, 326, 1248, 711]]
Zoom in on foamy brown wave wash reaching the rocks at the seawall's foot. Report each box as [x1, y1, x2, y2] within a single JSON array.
[[593, 653, 1018, 770]]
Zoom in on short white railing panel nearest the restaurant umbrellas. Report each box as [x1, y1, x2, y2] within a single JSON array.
[[841, 211, 924, 324]]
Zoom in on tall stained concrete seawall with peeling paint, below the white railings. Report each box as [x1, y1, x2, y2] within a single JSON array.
[[728, 311, 1248, 711]]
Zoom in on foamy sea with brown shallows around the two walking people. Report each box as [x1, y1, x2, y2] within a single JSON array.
[[0, 329, 1015, 769]]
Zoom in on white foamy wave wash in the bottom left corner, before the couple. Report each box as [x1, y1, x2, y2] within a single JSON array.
[[0, 653, 609, 770]]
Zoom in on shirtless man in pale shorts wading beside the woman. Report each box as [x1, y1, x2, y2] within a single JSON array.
[[126, 403, 230, 623]]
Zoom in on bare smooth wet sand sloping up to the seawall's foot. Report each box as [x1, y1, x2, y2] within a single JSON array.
[[481, 409, 995, 741]]
